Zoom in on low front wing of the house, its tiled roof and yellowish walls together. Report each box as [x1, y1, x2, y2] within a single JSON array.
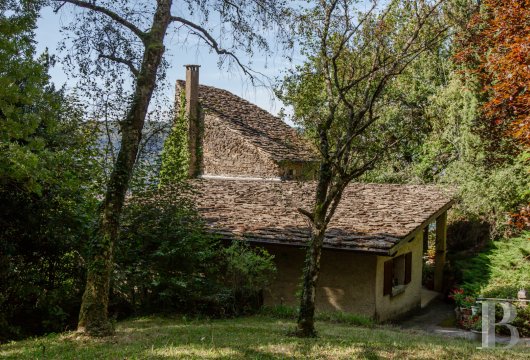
[[192, 179, 451, 321]]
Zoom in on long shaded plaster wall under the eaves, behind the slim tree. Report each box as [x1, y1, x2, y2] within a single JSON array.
[[258, 245, 377, 317]]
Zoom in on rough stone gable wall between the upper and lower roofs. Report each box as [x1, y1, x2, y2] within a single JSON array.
[[202, 114, 281, 178]]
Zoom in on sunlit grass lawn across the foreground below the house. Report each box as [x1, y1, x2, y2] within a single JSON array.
[[0, 315, 530, 360]]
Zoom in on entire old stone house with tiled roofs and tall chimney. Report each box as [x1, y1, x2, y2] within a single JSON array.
[[177, 66, 452, 321]]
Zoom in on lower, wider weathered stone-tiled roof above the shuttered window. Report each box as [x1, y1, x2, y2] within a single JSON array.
[[192, 180, 452, 255]]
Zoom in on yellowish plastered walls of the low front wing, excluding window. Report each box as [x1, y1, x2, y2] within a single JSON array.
[[263, 231, 423, 321]]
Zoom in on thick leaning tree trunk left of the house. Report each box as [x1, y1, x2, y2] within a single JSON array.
[[78, 0, 172, 336]]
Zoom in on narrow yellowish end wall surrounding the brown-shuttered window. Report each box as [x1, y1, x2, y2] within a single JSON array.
[[375, 231, 423, 321]]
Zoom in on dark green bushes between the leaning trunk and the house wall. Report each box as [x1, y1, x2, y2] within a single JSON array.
[[111, 185, 274, 316]]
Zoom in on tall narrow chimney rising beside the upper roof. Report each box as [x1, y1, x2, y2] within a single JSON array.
[[185, 65, 203, 178]]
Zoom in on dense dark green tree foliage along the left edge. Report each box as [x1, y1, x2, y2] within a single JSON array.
[[0, 1, 96, 342]]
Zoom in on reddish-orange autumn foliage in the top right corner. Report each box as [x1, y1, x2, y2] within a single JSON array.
[[457, 0, 530, 147]]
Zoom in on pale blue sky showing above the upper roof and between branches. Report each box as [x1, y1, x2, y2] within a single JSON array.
[[36, 4, 293, 114]]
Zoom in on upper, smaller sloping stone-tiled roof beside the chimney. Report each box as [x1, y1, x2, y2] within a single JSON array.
[[177, 80, 315, 161]]
